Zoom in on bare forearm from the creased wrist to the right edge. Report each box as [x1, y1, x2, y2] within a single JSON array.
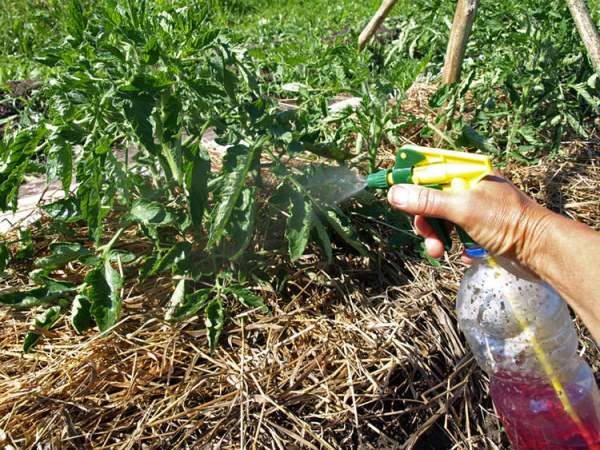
[[525, 214, 600, 344]]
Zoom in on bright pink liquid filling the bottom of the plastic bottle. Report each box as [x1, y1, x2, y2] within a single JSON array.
[[490, 376, 600, 450]]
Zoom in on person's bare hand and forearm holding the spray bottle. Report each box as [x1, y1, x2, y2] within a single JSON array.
[[388, 175, 600, 343]]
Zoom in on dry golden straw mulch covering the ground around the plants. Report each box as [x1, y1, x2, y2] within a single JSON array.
[[0, 125, 600, 449]]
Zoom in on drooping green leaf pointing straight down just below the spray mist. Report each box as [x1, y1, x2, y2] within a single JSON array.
[[285, 191, 313, 261]]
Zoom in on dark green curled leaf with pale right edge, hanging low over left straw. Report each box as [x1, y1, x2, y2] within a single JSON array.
[[85, 260, 123, 331]]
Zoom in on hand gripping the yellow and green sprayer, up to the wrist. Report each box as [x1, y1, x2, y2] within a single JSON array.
[[388, 175, 553, 266]]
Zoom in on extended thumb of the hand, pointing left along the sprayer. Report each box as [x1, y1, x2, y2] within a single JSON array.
[[388, 184, 460, 222]]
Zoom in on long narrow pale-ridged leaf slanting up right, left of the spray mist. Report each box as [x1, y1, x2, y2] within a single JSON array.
[[207, 145, 260, 249]]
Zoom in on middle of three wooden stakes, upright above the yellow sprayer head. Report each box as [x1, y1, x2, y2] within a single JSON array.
[[442, 0, 479, 84]]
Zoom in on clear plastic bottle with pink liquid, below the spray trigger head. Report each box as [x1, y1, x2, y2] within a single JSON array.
[[456, 252, 600, 450]]
